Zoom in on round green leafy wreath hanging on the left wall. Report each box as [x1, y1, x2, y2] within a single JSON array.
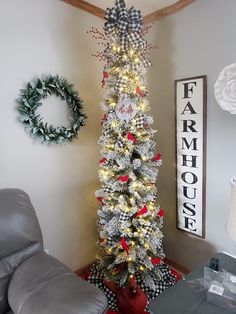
[[18, 75, 87, 144]]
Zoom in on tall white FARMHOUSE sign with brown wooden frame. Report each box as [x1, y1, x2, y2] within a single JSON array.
[[175, 75, 207, 238]]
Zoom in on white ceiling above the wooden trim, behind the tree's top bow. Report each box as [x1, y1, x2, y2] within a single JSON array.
[[87, 0, 178, 15]]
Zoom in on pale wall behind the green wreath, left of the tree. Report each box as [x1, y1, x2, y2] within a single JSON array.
[[0, 0, 102, 269]]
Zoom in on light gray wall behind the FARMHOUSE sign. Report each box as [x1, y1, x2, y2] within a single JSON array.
[[149, 0, 236, 267]]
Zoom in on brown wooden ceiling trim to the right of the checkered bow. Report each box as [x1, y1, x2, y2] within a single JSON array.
[[143, 0, 196, 24]]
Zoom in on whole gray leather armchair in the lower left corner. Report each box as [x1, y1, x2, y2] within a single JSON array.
[[0, 189, 107, 314]]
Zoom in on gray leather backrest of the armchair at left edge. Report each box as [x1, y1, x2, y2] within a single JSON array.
[[0, 189, 43, 313]]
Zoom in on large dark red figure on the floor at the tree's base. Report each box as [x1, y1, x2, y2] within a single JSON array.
[[104, 278, 147, 314]]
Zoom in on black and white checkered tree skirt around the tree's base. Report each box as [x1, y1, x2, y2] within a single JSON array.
[[88, 263, 176, 311]]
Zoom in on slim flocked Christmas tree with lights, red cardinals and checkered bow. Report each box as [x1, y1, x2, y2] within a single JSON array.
[[87, 0, 178, 310]]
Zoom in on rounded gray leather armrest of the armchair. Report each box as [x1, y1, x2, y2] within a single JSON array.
[[8, 252, 107, 314]]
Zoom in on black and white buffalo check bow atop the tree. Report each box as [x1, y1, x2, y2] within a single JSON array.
[[105, 0, 147, 51]]
